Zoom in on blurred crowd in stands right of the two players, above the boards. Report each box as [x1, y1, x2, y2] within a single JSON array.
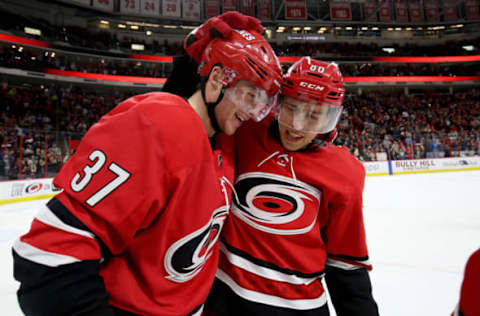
[[336, 89, 480, 161]]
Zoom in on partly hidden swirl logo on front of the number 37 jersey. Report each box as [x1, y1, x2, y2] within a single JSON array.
[[164, 206, 228, 282]]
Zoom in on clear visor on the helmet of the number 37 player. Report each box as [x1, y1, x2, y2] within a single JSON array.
[[224, 80, 277, 122]]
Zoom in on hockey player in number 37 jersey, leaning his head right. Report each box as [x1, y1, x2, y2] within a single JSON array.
[[13, 12, 281, 316]]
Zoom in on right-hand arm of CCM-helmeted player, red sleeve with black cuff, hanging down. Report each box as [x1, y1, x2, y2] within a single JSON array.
[[323, 163, 378, 316]]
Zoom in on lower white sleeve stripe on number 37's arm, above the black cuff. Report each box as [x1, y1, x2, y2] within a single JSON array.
[[13, 239, 80, 267]]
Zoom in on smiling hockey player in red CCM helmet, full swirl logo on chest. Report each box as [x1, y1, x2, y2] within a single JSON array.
[[207, 57, 378, 316]]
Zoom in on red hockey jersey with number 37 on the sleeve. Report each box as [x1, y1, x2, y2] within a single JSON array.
[[14, 93, 234, 315]]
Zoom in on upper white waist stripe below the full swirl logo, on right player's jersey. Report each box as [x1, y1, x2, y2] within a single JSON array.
[[220, 242, 324, 285]]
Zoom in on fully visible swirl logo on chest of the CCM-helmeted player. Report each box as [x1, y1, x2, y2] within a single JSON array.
[[232, 172, 321, 235]]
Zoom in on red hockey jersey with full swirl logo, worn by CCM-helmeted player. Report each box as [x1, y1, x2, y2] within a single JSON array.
[[217, 117, 371, 310]]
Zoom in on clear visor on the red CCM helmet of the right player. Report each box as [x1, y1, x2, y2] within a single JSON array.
[[278, 98, 343, 134]]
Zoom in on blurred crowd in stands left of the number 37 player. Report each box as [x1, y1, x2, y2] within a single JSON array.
[[0, 85, 128, 179]]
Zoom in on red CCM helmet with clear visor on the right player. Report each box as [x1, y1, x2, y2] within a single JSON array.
[[278, 57, 345, 134]]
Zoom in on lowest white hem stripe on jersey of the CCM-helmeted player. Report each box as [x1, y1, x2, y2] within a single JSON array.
[[217, 269, 327, 310]]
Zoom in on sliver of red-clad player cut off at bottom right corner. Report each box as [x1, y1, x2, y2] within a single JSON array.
[[452, 249, 480, 316]]
